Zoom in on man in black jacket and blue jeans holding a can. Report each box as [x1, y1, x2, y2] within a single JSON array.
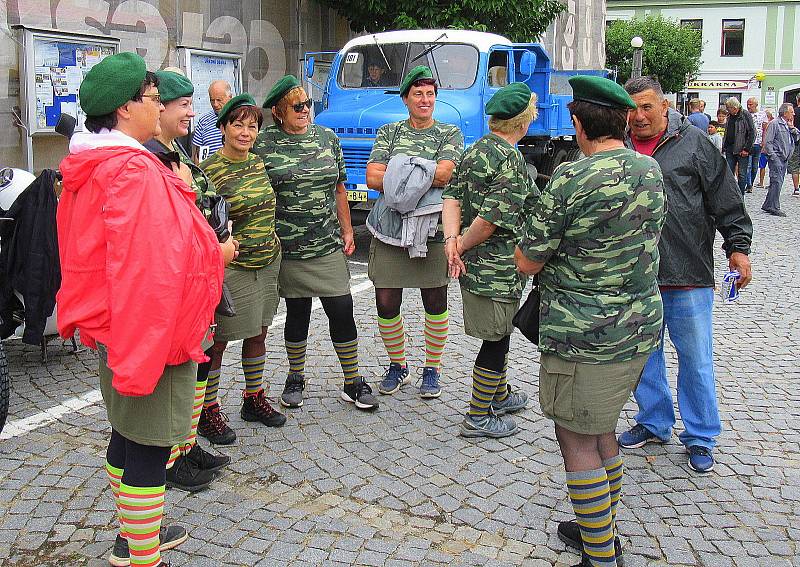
[[619, 77, 753, 473]]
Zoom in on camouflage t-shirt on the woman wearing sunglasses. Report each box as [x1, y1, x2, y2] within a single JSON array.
[[251, 124, 347, 260]]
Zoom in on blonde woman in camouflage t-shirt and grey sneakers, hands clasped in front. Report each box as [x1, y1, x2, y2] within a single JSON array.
[[442, 83, 539, 438]]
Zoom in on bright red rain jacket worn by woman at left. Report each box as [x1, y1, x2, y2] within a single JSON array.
[[56, 146, 224, 396]]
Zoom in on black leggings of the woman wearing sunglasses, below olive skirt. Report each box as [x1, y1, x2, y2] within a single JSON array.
[[283, 293, 358, 343]]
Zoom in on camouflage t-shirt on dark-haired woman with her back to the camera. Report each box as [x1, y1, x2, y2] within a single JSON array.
[[519, 149, 666, 364]]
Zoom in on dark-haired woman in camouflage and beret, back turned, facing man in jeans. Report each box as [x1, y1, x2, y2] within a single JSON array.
[[516, 75, 664, 567]]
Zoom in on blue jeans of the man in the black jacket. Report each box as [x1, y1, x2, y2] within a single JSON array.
[[634, 287, 722, 449]]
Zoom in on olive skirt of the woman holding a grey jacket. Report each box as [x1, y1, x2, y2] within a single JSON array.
[[368, 238, 449, 289]]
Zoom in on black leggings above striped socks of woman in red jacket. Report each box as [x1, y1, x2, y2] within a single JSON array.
[[106, 429, 171, 487]]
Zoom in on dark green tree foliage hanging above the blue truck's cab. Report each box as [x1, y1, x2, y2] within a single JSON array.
[[318, 0, 566, 42]]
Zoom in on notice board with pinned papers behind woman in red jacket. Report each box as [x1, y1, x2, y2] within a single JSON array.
[[21, 29, 119, 134]]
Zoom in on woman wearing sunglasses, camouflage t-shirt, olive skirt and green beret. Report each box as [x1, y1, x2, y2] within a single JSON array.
[[252, 75, 378, 410]]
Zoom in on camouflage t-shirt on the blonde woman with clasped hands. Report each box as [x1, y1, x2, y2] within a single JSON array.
[[443, 134, 539, 300]]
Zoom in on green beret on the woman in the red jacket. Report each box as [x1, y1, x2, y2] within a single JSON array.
[[78, 51, 147, 116]]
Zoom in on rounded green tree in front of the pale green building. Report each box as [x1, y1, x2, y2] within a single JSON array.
[[606, 16, 703, 93]]
